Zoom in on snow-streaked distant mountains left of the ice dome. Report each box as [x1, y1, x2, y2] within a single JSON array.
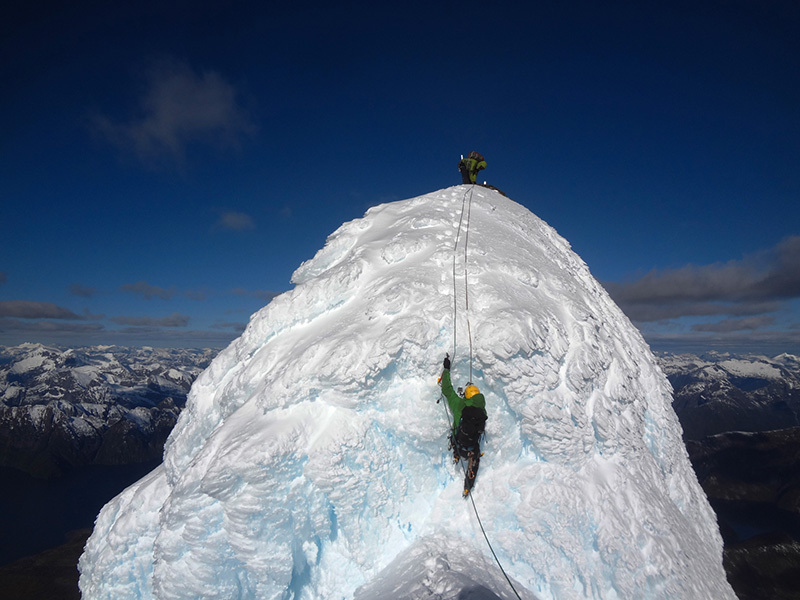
[[0, 344, 217, 477]]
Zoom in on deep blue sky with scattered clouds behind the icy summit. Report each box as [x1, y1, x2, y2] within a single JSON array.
[[0, 0, 800, 353]]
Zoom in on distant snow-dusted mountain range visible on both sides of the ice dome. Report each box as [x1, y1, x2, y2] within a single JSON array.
[[0, 344, 800, 477]]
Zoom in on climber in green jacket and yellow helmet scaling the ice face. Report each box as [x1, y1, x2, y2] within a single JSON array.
[[439, 354, 487, 496]]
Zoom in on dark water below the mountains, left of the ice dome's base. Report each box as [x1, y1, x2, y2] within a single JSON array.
[[0, 460, 161, 565]]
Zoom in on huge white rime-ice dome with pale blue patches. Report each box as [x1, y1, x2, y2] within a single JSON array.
[[79, 185, 735, 600]]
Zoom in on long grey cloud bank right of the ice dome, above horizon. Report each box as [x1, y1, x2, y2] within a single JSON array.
[[605, 236, 800, 322]]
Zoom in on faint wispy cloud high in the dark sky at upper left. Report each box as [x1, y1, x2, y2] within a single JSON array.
[[94, 59, 256, 162]]
